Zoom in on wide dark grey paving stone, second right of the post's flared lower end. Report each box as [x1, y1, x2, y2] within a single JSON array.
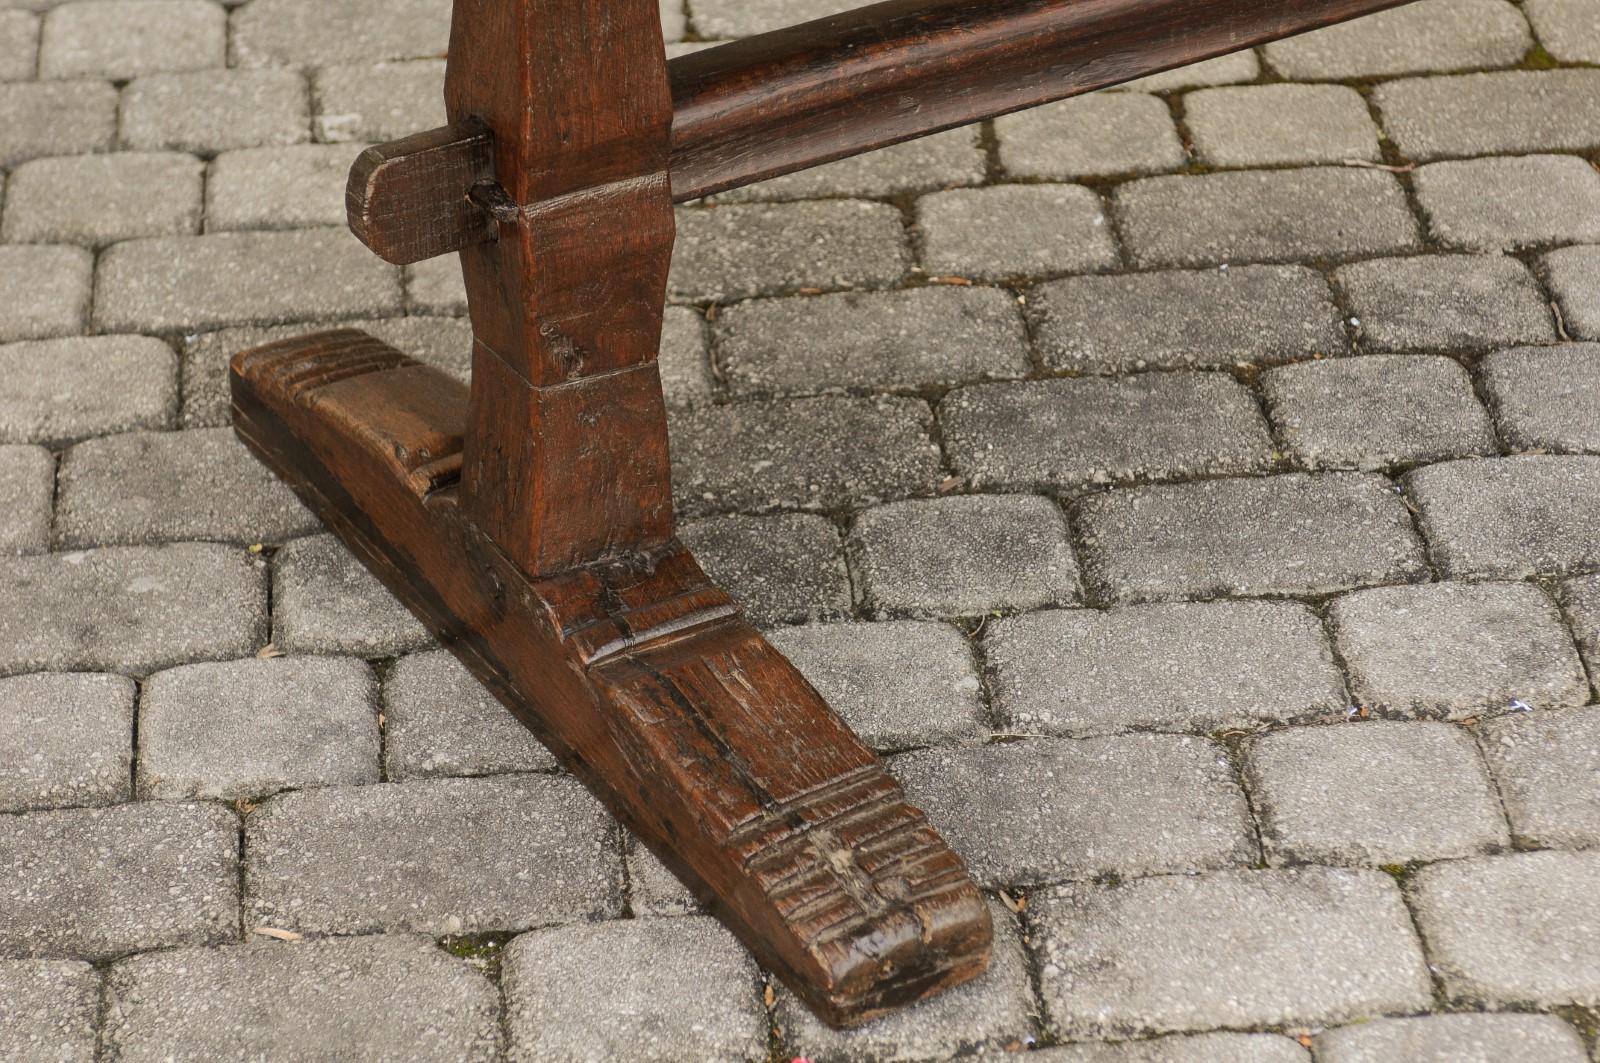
[[939, 373, 1272, 490]]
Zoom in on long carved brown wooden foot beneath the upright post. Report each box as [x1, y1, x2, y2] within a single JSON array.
[[232, 330, 990, 1025]]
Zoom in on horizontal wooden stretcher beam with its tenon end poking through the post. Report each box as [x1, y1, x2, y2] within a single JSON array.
[[347, 0, 1410, 263]]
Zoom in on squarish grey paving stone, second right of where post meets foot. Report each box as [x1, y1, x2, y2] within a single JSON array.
[[848, 495, 1078, 616]]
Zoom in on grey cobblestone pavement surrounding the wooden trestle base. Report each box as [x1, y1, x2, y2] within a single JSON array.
[[0, 0, 1600, 1063]]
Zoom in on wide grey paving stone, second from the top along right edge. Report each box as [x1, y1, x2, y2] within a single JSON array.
[[1373, 70, 1600, 158]]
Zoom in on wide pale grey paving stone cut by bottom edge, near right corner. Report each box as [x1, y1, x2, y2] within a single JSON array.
[[1315, 1015, 1586, 1063]]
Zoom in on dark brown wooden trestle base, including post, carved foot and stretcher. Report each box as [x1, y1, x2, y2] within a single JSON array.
[[232, 0, 1420, 1025]]
